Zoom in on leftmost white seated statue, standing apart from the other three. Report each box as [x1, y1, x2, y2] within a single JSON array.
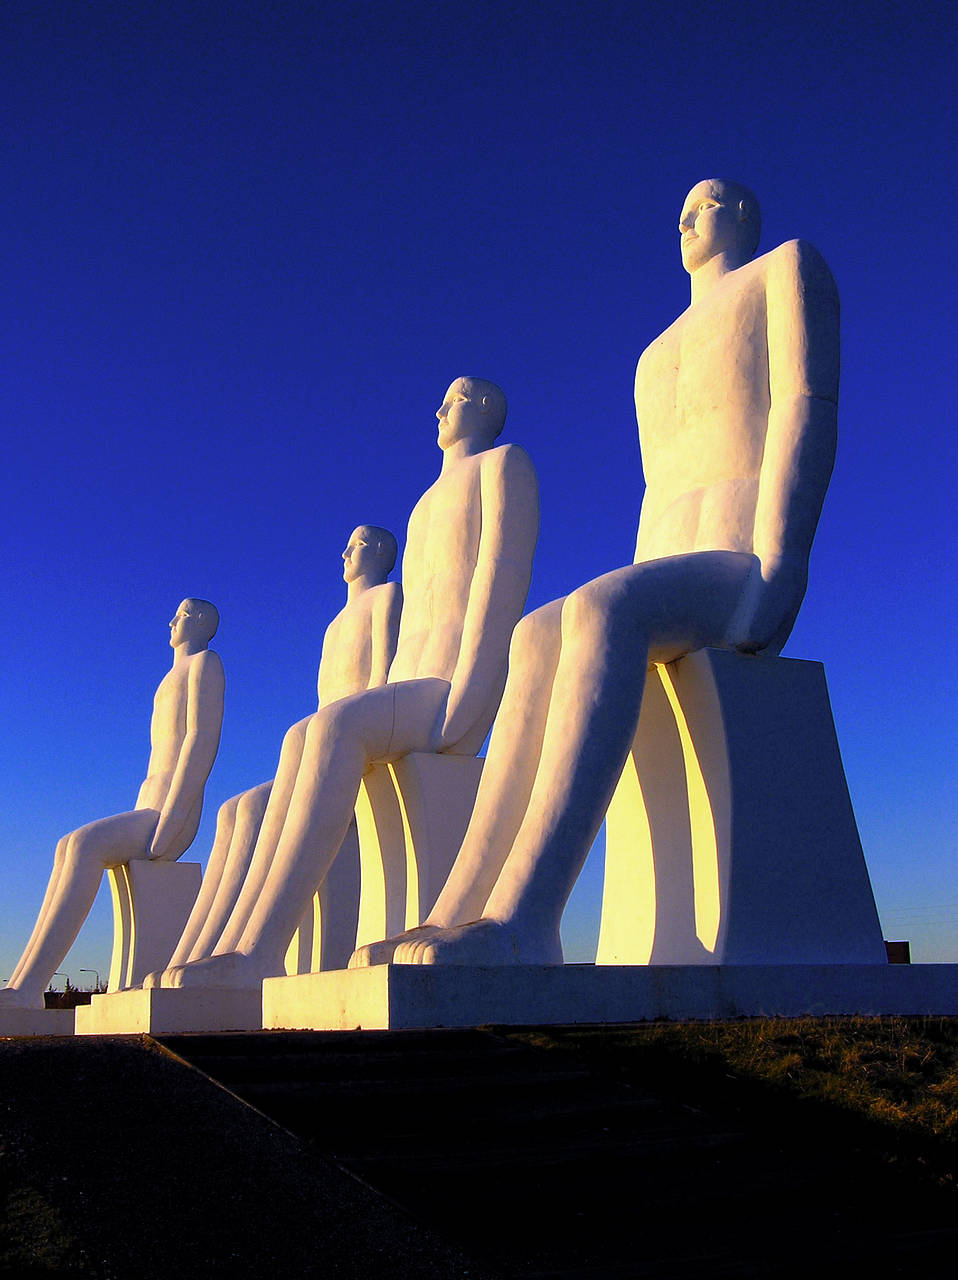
[[0, 599, 224, 1010]]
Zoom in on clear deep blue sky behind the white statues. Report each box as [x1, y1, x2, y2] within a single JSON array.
[[0, 0, 958, 982]]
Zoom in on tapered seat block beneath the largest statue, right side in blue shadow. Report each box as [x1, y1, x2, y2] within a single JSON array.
[[597, 649, 886, 965]]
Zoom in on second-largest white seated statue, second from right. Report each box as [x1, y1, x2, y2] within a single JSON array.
[[165, 378, 539, 988]]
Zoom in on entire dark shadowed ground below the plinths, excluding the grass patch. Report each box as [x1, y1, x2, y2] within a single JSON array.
[[0, 1028, 958, 1280]]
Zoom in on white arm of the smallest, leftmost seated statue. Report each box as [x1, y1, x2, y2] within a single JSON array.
[[150, 649, 225, 861]]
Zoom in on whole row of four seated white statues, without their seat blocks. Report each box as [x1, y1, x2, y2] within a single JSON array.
[[0, 179, 881, 1006]]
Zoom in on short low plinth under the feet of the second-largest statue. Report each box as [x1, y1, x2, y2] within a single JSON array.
[[77, 987, 263, 1036]]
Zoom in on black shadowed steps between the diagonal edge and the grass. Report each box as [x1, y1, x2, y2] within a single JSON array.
[[165, 1029, 958, 1280]]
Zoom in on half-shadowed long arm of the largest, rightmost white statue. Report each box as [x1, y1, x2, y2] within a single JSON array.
[[731, 241, 839, 653]]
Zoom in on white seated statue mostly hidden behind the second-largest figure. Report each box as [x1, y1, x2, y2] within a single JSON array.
[[151, 525, 402, 987]]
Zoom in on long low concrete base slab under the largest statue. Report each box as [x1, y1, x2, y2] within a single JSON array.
[[263, 964, 958, 1030]]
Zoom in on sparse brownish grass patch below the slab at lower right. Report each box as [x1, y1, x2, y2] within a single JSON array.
[[503, 1018, 958, 1187]]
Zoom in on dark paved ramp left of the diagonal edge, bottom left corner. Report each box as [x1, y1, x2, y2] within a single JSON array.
[[0, 1037, 488, 1280]]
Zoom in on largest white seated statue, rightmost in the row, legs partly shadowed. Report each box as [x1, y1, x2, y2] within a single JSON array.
[[350, 179, 839, 968]]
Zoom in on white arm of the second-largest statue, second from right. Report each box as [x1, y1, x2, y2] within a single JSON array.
[[439, 444, 539, 749]]
